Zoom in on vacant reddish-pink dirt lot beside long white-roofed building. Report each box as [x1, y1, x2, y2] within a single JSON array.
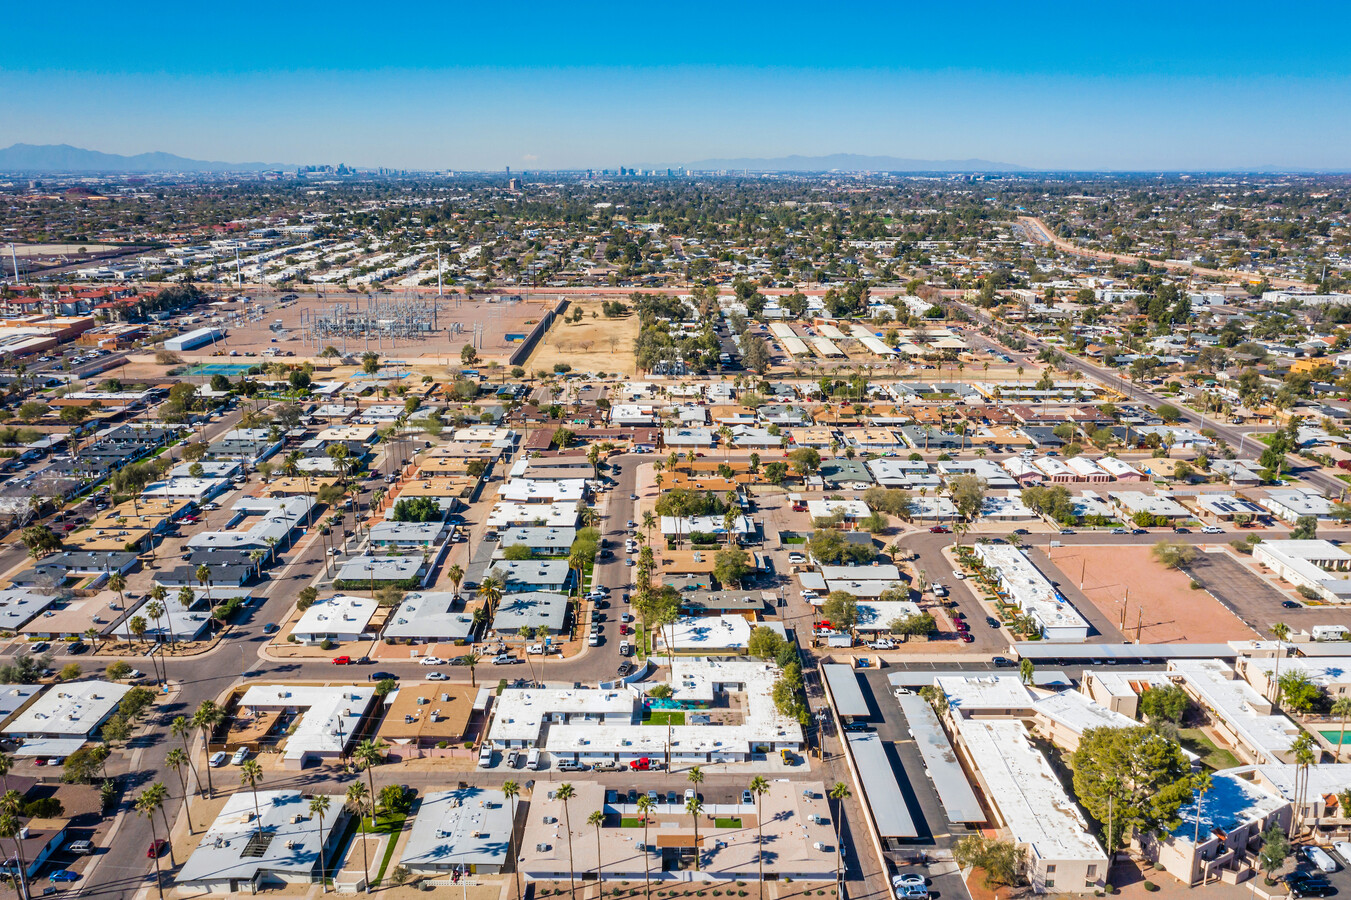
[[1047, 545, 1256, 643]]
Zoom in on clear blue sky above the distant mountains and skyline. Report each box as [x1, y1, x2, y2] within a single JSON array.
[[10, 0, 1351, 169]]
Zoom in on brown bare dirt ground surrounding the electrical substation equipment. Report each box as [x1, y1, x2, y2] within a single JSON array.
[[182, 293, 553, 366]]
